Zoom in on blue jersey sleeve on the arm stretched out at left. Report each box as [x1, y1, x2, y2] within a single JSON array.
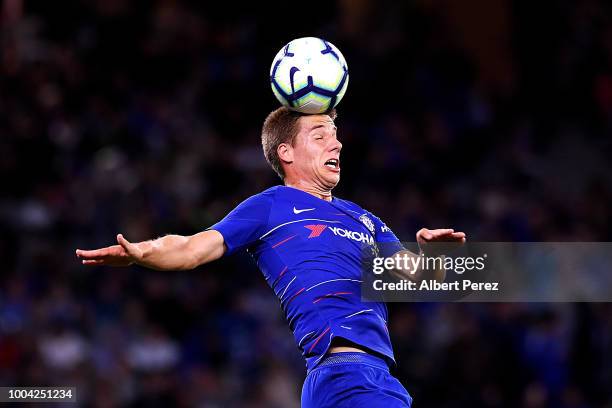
[[208, 193, 272, 255]]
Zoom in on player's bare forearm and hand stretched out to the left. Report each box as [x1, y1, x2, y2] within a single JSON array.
[[76, 230, 225, 270]]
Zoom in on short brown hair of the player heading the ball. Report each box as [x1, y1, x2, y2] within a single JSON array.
[[261, 106, 337, 180]]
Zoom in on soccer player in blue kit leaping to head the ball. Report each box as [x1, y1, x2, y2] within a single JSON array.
[[76, 107, 465, 408]]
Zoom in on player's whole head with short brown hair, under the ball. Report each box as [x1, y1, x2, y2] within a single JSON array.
[[261, 107, 342, 190]]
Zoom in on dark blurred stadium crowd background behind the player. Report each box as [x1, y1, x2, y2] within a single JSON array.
[[0, 0, 612, 408]]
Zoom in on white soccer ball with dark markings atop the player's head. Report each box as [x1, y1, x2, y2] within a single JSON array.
[[270, 37, 348, 114]]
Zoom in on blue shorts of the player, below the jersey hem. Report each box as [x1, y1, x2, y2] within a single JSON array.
[[302, 353, 412, 408]]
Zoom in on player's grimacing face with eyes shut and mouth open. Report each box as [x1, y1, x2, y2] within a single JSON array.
[[293, 115, 342, 190]]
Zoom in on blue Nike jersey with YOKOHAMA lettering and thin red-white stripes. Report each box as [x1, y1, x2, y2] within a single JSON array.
[[210, 186, 403, 370]]
